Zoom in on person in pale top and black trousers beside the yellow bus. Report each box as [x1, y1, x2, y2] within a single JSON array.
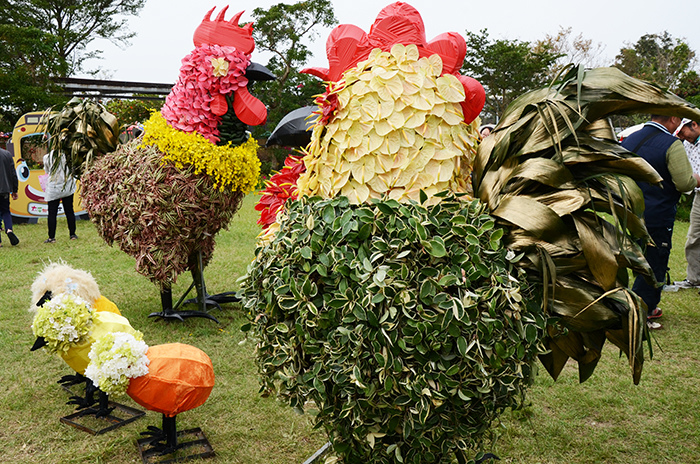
[[44, 151, 78, 243]]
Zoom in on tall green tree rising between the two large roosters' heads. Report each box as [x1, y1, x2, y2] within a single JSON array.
[[252, 0, 337, 138]]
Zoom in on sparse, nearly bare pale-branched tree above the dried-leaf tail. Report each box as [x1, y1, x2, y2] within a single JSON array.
[[534, 26, 605, 80]]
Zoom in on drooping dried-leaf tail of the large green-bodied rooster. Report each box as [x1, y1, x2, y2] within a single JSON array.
[[474, 66, 700, 383]]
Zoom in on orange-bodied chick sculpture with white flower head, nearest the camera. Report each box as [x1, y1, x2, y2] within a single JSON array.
[[85, 333, 214, 455]]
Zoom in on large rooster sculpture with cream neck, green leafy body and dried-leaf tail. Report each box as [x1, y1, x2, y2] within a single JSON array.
[[243, 2, 700, 463]]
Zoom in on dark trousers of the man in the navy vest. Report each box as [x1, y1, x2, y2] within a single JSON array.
[[632, 227, 673, 312]]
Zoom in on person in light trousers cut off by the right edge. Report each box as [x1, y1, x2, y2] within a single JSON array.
[[674, 119, 700, 288]]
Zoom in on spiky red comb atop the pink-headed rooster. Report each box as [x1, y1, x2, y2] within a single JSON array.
[[194, 5, 255, 55]]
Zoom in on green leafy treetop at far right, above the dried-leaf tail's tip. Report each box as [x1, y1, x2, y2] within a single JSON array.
[[615, 31, 695, 89]]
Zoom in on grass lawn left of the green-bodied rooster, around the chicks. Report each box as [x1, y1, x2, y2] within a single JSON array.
[[0, 195, 326, 464]]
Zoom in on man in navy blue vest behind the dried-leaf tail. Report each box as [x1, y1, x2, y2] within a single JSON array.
[[622, 115, 700, 329]]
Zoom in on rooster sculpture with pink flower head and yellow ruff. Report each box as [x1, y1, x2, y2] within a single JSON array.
[[81, 7, 274, 320]]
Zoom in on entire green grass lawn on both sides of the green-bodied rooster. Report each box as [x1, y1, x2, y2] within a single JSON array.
[[0, 196, 700, 464]]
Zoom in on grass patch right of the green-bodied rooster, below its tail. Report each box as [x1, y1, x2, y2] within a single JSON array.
[[495, 222, 700, 464]]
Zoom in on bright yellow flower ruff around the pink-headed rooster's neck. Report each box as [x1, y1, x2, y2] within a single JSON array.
[[143, 112, 260, 194]]
